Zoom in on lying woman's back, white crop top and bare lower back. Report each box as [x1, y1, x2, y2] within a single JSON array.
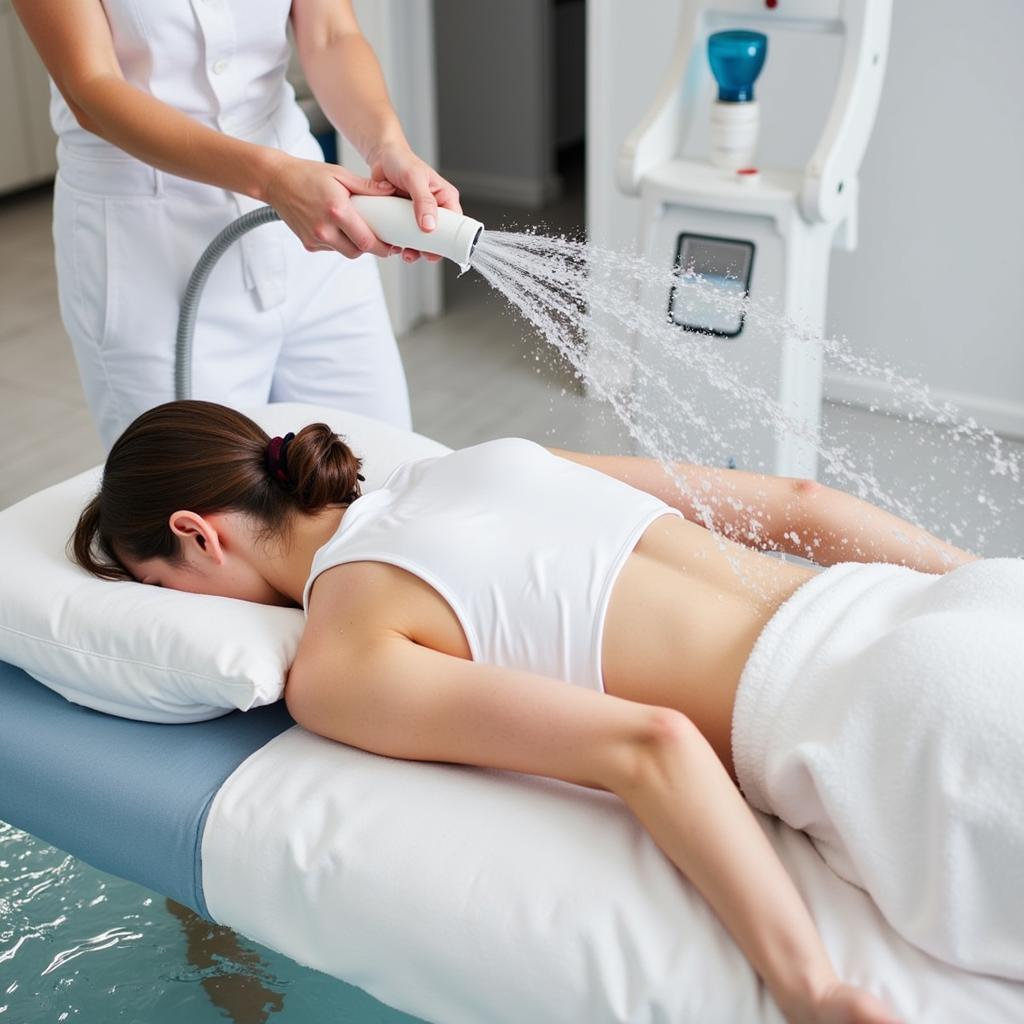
[[304, 438, 808, 764]]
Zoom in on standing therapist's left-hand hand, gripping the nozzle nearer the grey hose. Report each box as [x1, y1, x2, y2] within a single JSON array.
[[263, 154, 394, 259]]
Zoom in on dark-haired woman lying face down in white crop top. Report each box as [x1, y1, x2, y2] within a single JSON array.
[[73, 401, 973, 1022]]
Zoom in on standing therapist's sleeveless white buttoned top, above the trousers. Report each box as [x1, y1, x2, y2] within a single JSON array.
[[50, 0, 311, 310]]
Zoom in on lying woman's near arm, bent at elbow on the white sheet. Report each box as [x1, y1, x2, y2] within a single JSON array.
[[285, 563, 880, 1021]]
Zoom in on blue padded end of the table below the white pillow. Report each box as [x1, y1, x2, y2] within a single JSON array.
[[0, 662, 294, 919]]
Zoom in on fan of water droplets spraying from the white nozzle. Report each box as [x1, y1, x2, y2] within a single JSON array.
[[471, 230, 1024, 577]]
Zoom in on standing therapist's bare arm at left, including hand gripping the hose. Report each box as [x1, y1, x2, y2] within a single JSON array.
[[14, 0, 394, 257]]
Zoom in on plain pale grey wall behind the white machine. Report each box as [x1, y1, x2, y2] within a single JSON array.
[[587, 0, 1024, 437]]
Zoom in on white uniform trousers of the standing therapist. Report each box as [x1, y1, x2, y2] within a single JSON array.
[[53, 135, 411, 447]]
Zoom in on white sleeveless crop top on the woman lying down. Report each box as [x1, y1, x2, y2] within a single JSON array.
[[302, 437, 680, 690]]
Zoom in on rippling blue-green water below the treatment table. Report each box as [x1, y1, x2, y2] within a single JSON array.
[[0, 821, 422, 1024]]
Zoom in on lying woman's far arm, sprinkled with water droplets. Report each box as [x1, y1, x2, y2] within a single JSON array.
[[551, 449, 977, 572]]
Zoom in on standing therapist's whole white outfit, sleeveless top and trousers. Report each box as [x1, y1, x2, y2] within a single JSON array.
[[50, 0, 410, 446]]
